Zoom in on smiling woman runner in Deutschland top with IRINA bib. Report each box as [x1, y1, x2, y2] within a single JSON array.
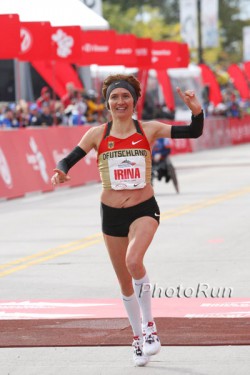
[[51, 74, 204, 366]]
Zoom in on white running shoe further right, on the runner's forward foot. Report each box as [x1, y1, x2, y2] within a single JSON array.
[[142, 322, 161, 356]]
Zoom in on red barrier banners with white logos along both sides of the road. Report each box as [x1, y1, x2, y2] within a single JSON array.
[[0, 115, 250, 199]]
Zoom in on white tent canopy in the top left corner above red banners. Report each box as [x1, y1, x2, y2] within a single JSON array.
[[0, 0, 109, 30]]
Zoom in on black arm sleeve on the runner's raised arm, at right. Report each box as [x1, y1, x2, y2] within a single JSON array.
[[171, 111, 204, 138]]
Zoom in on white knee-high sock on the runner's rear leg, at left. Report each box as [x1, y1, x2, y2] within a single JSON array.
[[122, 294, 143, 337]]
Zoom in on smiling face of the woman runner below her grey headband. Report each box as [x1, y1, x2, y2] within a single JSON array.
[[108, 87, 134, 117]]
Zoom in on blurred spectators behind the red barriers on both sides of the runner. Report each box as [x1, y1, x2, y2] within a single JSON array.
[[0, 73, 250, 129]]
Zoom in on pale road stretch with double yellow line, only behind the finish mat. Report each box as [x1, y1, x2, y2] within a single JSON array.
[[0, 145, 250, 300]]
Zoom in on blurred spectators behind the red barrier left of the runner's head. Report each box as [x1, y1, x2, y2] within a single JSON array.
[[0, 82, 107, 129]]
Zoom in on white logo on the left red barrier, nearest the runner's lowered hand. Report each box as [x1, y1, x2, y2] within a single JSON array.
[[26, 137, 49, 184]]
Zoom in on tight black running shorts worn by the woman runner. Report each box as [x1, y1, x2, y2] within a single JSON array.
[[101, 196, 160, 237]]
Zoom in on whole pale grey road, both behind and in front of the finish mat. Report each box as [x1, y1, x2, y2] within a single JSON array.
[[0, 144, 250, 375]]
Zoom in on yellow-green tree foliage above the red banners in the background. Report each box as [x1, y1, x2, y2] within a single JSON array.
[[103, 0, 250, 63]]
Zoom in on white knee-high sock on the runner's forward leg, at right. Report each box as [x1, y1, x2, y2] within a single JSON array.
[[133, 274, 153, 324]]
